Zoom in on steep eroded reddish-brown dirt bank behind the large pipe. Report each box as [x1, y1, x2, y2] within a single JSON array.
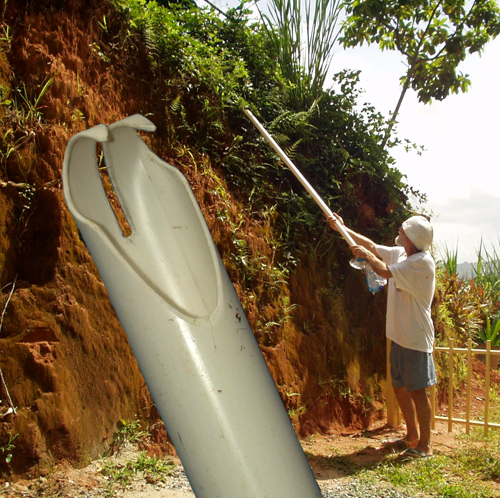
[[0, 0, 385, 476]]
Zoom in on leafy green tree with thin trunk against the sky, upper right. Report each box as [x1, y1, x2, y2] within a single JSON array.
[[340, 0, 500, 147]]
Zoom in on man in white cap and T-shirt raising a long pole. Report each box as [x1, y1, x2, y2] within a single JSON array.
[[328, 214, 436, 458]]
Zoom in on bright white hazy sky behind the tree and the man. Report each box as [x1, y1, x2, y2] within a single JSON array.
[[200, 0, 500, 263]]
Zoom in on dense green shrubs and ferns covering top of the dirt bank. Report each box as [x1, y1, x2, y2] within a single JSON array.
[[113, 0, 418, 245]]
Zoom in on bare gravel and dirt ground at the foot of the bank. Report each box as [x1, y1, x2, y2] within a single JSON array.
[[0, 424, 454, 498]]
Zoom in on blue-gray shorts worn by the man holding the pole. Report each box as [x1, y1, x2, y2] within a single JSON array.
[[391, 342, 437, 391]]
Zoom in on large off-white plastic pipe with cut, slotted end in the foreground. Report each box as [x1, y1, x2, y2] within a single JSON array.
[[63, 115, 321, 498]]
